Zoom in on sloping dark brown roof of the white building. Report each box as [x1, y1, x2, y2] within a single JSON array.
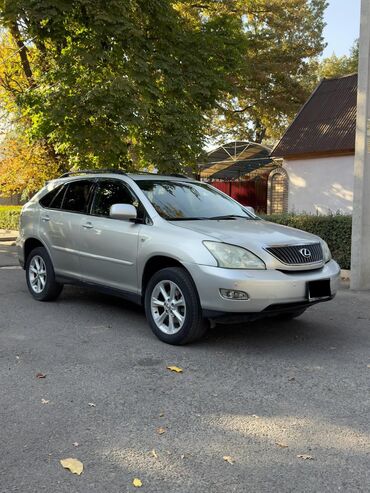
[[271, 74, 357, 157]]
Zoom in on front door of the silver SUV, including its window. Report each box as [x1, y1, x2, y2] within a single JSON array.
[[80, 179, 141, 293]]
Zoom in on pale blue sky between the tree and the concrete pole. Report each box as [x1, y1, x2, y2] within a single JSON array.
[[323, 0, 361, 57]]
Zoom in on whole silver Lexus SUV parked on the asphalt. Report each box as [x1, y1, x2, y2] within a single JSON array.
[[17, 171, 340, 344]]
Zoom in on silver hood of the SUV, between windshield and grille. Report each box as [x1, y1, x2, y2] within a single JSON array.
[[172, 218, 320, 251]]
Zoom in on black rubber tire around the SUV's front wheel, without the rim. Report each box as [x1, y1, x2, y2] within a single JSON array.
[[145, 267, 205, 345]]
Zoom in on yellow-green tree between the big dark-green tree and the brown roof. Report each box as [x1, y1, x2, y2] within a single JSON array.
[[204, 0, 327, 142]]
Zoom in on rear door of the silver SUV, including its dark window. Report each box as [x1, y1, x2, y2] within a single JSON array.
[[40, 179, 94, 279]]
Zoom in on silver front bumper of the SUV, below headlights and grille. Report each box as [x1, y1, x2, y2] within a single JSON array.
[[185, 260, 340, 313]]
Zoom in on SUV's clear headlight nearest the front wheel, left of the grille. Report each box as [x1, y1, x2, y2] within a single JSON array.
[[203, 241, 266, 269]]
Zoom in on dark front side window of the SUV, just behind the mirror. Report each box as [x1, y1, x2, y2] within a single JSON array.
[[91, 180, 138, 216]]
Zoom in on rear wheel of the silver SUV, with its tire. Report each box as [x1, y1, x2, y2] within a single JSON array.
[[26, 247, 63, 301]]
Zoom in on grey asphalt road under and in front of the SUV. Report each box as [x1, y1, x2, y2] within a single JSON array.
[[0, 244, 370, 493]]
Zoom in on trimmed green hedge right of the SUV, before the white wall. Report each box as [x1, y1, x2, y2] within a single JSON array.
[[261, 214, 352, 269]]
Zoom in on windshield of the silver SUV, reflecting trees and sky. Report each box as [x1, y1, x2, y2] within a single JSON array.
[[137, 180, 257, 221]]
